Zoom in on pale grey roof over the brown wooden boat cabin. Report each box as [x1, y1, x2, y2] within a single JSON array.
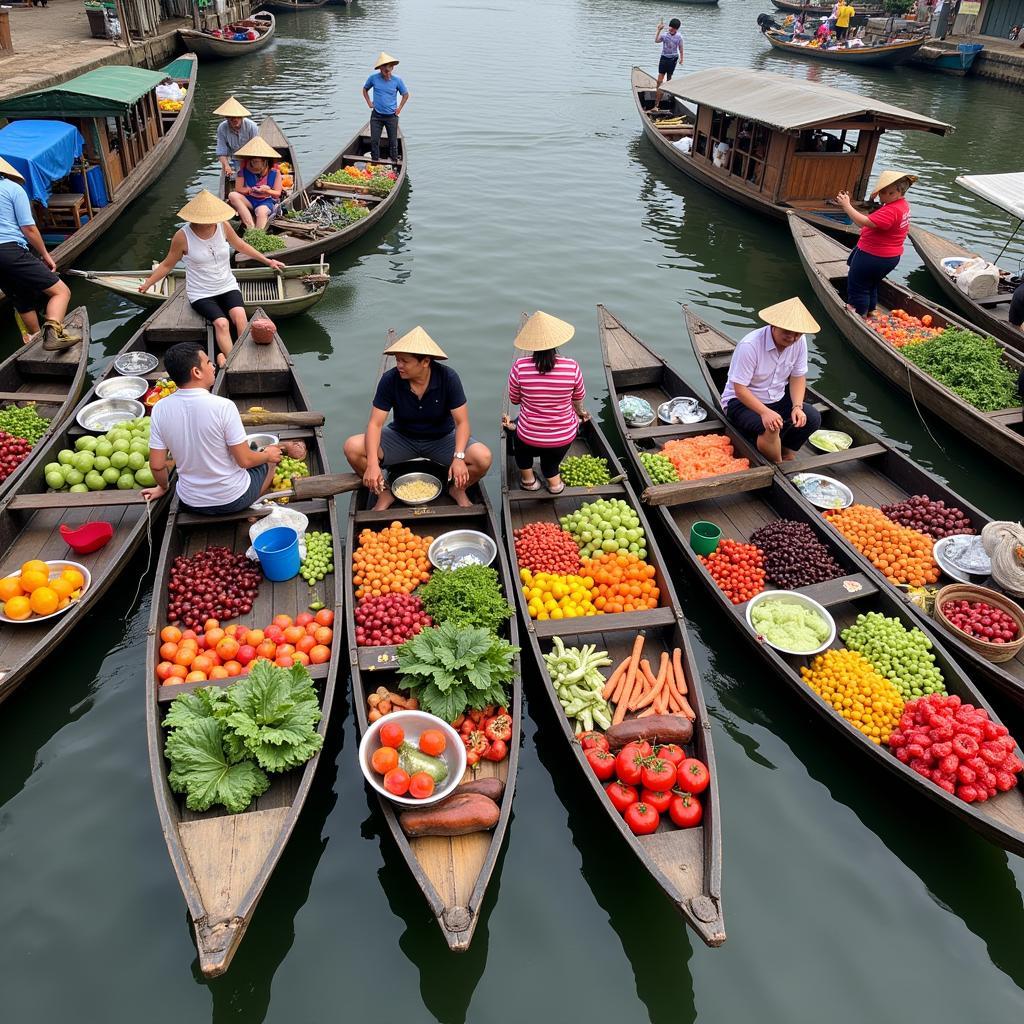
[[662, 68, 952, 135]]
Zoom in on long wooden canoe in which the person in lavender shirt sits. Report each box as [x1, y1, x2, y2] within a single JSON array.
[[684, 307, 1024, 705]]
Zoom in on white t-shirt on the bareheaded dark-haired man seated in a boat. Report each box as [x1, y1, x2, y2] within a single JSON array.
[[150, 387, 249, 508]]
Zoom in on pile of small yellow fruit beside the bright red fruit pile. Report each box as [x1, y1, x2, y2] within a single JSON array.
[[800, 650, 903, 745]]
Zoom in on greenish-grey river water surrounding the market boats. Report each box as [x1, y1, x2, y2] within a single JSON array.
[[0, 0, 1024, 1024]]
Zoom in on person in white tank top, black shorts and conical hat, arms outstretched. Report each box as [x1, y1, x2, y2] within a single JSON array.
[[138, 188, 285, 367]]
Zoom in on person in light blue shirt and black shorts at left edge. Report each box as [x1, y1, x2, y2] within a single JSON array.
[[0, 158, 82, 351]]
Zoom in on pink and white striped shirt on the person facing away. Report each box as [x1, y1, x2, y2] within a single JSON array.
[[509, 355, 587, 447]]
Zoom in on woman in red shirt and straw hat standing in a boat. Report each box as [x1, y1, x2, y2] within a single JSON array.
[[836, 171, 918, 316]]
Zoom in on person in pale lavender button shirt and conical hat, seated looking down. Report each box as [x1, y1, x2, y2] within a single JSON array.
[[722, 298, 821, 463]]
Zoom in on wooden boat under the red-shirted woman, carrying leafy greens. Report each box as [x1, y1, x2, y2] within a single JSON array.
[[790, 216, 1024, 474]]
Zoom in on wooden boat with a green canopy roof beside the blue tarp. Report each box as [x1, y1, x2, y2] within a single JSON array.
[[0, 53, 199, 301]]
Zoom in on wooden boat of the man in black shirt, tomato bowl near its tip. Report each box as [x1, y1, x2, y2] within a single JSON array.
[[345, 342, 523, 952]]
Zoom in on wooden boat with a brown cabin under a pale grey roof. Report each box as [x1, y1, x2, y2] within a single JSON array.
[[632, 68, 949, 244]]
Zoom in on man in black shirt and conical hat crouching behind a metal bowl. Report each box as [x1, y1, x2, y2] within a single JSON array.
[[345, 327, 492, 509]]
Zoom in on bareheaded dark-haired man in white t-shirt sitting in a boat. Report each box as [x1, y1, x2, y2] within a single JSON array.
[[142, 341, 306, 515]]
